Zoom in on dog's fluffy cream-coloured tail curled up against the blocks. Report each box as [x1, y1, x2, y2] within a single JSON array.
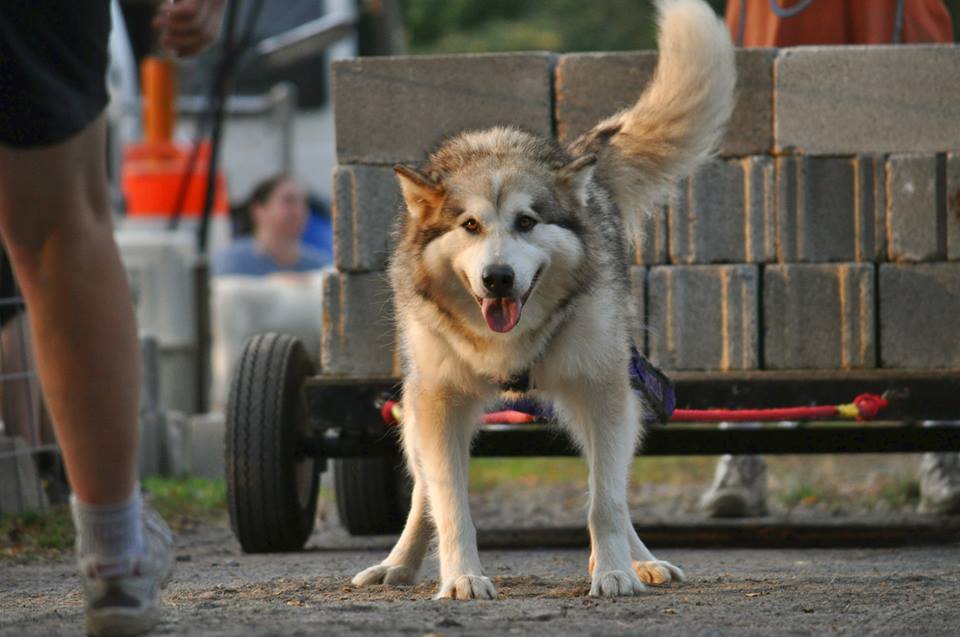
[[570, 0, 736, 240]]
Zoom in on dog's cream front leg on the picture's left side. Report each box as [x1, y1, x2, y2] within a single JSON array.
[[403, 386, 496, 599]]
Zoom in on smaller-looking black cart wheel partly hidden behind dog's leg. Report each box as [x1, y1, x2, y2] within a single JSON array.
[[333, 453, 413, 535]]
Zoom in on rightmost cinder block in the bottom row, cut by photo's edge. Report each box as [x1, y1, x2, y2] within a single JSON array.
[[880, 263, 960, 369]]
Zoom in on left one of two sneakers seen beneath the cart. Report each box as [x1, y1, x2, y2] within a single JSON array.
[[700, 455, 767, 518]]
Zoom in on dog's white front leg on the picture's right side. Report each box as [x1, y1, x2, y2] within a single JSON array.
[[561, 382, 644, 597]]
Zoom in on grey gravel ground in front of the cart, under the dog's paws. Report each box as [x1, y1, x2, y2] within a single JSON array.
[[0, 525, 960, 637]]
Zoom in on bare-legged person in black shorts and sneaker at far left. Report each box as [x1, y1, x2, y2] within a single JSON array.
[[0, 0, 225, 635]]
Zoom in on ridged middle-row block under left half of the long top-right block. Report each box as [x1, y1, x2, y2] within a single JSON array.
[[776, 156, 884, 262]]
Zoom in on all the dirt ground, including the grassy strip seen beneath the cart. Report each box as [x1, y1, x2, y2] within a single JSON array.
[[0, 456, 960, 637]]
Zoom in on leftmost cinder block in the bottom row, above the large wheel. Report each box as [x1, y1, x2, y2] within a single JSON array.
[[320, 272, 399, 377]]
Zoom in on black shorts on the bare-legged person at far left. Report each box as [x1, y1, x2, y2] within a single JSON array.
[[0, 0, 110, 148]]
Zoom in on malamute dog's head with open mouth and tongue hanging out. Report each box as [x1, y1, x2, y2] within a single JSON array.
[[395, 128, 595, 334]]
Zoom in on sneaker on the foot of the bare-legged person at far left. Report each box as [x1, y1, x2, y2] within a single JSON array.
[[79, 505, 173, 637]]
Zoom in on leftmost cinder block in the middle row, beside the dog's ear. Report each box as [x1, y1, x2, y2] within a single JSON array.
[[333, 166, 402, 272]]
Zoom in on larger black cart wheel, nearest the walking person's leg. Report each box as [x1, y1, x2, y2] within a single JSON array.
[[226, 334, 319, 553]]
